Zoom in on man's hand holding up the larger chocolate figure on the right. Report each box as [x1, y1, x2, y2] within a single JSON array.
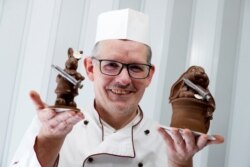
[[158, 128, 224, 167]]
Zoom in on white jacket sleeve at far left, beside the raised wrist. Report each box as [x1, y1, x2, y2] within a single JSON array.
[[9, 117, 41, 167]]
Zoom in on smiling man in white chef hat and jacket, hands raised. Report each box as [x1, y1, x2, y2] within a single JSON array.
[[12, 9, 223, 167]]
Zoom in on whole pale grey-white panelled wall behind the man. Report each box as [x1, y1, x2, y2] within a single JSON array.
[[0, 0, 250, 167]]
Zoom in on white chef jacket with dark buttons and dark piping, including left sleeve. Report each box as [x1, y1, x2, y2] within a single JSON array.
[[10, 103, 167, 167]]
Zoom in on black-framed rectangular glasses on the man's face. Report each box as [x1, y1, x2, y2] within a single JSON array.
[[92, 57, 152, 79]]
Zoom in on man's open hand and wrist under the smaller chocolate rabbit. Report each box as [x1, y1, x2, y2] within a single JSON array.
[[30, 91, 84, 167]]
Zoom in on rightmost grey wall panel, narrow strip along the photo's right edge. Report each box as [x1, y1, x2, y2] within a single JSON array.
[[225, 0, 250, 167]]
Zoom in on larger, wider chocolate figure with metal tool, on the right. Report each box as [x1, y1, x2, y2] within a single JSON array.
[[169, 66, 215, 133]]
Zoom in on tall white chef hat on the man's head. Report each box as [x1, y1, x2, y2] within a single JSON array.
[[95, 9, 150, 46]]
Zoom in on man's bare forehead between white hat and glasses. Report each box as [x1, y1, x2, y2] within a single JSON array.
[[97, 40, 148, 63]]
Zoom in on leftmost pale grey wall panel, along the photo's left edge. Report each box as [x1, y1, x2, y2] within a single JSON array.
[[0, 0, 29, 165]]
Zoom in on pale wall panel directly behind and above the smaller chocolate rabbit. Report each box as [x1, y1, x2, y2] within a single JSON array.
[[47, 0, 88, 104]]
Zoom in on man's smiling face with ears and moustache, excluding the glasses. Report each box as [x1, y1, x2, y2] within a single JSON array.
[[84, 40, 154, 124]]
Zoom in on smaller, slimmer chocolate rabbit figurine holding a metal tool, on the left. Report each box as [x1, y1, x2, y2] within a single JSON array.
[[54, 48, 84, 110]]
